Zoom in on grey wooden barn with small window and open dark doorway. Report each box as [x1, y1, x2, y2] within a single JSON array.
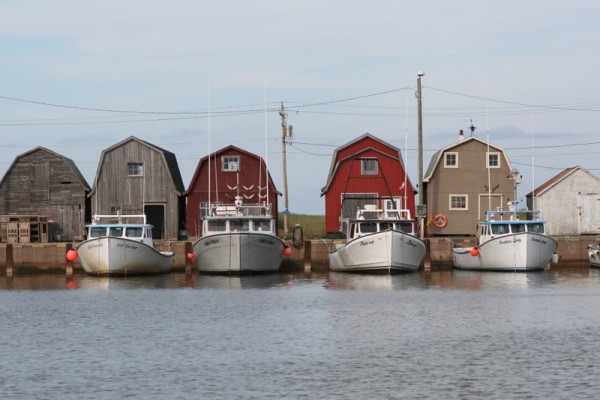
[[89, 136, 185, 240]]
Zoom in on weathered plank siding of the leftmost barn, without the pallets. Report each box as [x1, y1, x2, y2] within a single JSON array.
[[0, 148, 89, 241]]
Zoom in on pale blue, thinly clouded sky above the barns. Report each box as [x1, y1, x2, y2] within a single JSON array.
[[0, 0, 600, 214]]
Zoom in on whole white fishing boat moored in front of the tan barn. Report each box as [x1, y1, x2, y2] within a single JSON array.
[[452, 203, 558, 271]]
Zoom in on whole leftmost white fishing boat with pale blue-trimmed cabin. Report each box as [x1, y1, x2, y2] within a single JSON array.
[[74, 214, 173, 275]]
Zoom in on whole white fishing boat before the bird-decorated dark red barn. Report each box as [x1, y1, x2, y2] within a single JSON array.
[[191, 196, 291, 273]]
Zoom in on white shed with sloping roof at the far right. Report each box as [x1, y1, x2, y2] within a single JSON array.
[[527, 166, 600, 235]]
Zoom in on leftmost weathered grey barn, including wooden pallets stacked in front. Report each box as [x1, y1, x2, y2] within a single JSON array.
[[0, 147, 90, 242]]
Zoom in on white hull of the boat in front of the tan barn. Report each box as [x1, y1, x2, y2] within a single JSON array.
[[452, 232, 557, 271]]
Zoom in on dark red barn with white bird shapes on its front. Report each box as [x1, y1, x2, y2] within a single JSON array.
[[184, 145, 280, 237]]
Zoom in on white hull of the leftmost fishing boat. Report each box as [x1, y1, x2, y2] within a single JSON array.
[[77, 237, 173, 275]]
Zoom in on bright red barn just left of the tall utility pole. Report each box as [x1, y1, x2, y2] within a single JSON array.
[[321, 133, 415, 236]]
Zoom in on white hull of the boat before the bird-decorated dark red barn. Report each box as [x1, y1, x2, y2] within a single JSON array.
[[193, 232, 286, 273]]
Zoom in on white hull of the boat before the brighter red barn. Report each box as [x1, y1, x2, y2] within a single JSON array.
[[329, 230, 425, 272]]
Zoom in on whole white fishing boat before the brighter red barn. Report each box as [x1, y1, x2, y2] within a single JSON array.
[[329, 204, 425, 272]]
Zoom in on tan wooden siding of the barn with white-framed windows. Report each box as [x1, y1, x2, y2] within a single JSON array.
[[425, 140, 514, 235]]
